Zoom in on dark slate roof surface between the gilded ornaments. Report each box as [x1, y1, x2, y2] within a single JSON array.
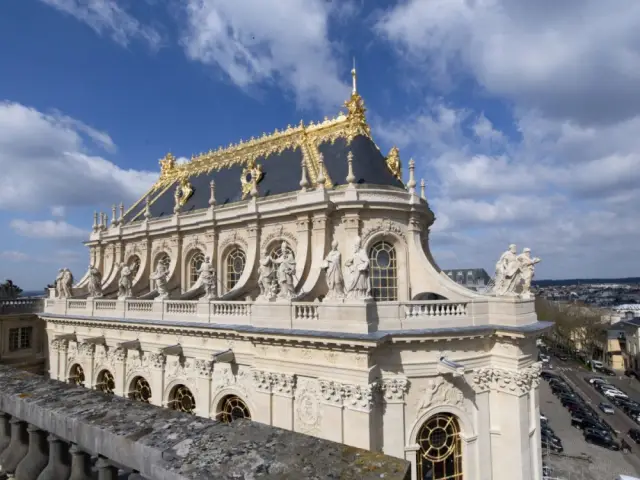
[[125, 135, 404, 222]]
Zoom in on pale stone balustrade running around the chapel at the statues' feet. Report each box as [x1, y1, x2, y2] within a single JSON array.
[[44, 297, 536, 334]]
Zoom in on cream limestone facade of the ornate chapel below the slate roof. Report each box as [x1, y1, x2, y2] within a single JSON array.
[[42, 83, 549, 480]]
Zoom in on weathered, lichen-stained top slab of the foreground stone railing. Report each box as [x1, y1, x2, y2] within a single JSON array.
[[0, 366, 409, 480]]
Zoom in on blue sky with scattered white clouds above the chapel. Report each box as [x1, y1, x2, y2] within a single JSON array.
[[0, 0, 640, 289]]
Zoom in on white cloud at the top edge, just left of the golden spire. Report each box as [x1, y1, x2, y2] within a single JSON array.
[[182, 0, 348, 109]]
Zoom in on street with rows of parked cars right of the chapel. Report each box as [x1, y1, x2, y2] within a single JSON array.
[[540, 346, 640, 480]]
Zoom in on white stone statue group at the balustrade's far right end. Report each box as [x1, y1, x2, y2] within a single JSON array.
[[493, 244, 540, 299]]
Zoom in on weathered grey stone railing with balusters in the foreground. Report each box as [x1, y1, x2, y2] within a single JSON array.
[[0, 366, 410, 480]]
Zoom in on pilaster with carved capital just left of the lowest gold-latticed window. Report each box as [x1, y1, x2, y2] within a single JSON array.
[[374, 377, 409, 458]]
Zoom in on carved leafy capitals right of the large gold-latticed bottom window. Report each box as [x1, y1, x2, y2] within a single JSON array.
[[472, 362, 542, 395]]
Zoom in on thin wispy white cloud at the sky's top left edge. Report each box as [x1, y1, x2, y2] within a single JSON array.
[[40, 0, 162, 48]]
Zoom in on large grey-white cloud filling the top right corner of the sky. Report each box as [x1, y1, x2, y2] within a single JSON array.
[[376, 0, 640, 124]]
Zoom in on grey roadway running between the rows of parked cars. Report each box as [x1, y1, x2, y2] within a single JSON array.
[[551, 357, 640, 472]]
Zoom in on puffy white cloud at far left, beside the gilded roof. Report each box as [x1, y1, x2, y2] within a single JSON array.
[[0, 102, 157, 210]]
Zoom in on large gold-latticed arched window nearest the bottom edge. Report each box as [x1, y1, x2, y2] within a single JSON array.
[[417, 413, 462, 480]]
